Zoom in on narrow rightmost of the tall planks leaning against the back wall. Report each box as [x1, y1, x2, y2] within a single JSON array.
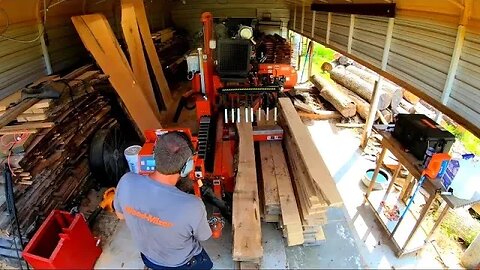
[[130, 0, 173, 110]]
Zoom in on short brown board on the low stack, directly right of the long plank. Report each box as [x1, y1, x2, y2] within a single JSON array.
[[259, 142, 280, 215]]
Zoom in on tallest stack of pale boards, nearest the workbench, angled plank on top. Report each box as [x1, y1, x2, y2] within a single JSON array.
[[277, 98, 343, 245]]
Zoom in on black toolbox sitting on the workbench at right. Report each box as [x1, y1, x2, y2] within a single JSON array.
[[393, 114, 455, 160]]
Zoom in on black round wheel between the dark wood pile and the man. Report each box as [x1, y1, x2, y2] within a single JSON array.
[[88, 126, 128, 187]]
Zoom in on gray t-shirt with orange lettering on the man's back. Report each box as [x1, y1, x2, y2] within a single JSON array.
[[114, 173, 212, 267]]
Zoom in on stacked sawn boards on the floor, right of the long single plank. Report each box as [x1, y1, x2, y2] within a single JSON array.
[[260, 98, 342, 246]]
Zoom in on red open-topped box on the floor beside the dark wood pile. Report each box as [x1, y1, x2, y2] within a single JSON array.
[[22, 210, 102, 269]]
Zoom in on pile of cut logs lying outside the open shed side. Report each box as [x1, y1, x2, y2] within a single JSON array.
[[296, 56, 429, 124]]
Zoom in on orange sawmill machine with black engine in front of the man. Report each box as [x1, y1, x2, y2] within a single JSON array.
[[139, 12, 297, 237]]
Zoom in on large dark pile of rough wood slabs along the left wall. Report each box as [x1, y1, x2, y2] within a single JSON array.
[[0, 67, 116, 245]]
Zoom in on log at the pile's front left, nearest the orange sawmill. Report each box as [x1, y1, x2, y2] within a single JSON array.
[[310, 75, 357, 117]]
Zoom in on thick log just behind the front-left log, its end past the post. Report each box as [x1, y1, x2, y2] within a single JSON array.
[[330, 66, 392, 110]]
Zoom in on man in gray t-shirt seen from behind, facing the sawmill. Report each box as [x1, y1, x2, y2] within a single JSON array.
[[114, 132, 213, 269]]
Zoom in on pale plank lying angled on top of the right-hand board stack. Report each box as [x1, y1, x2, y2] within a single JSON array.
[[278, 98, 343, 206]]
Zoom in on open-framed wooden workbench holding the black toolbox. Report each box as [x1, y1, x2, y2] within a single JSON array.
[[364, 131, 480, 257]]
